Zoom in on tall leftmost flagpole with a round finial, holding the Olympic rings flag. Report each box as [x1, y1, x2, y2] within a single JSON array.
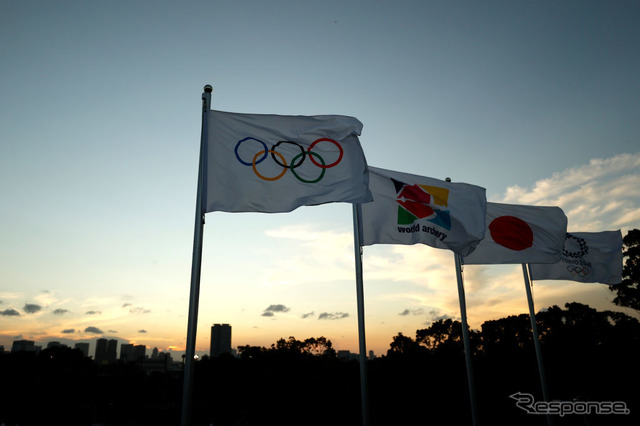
[[180, 84, 213, 426]]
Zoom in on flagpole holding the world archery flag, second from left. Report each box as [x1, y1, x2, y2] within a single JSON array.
[[353, 204, 369, 426]]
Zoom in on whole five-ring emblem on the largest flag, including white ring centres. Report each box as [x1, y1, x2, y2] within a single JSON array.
[[234, 137, 344, 183]]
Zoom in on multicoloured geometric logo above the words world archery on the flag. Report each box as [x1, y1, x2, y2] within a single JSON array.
[[391, 178, 451, 230]]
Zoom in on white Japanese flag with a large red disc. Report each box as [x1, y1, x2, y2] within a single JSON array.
[[464, 203, 567, 264]]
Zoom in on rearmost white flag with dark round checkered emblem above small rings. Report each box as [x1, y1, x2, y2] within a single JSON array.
[[529, 230, 622, 284]]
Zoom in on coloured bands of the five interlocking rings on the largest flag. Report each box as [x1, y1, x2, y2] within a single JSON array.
[[233, 137, 344, 183]]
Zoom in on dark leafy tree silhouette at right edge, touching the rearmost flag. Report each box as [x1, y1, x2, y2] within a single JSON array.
[[609, 229, 640, 311]]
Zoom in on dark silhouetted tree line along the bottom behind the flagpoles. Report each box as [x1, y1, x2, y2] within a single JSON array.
[[0, 303, 640, 426]]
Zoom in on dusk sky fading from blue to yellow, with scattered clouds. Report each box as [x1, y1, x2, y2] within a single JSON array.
[[0, 0, 640, 359]]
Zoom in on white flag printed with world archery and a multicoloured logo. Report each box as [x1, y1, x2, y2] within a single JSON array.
[[360, 167, 487, 254]]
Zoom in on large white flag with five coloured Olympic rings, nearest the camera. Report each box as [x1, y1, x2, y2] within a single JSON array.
[[204, 111, 371, 213]]
